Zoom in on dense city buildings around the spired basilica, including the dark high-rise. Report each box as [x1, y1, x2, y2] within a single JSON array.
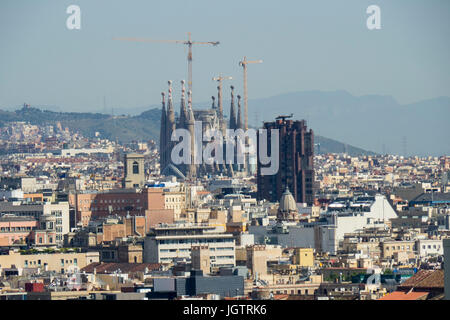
[[0, 105, 450, 300]]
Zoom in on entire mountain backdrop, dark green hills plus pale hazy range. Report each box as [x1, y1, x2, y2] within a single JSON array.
[[0, 90, 450, 156]]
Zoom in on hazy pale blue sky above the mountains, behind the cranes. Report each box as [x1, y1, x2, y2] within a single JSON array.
[[0, 0, 450, 111]]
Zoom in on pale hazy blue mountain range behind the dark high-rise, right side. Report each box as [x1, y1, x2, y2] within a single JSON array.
[[249, 91, 450, 156]]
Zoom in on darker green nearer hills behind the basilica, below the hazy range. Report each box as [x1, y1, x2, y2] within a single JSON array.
[[0, 107, 374, 155]]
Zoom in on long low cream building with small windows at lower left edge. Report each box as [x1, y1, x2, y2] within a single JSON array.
[[0, 250, 100, 274]]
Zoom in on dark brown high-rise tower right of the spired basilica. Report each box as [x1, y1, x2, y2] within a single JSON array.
[[257, 116, 314, 205]]
